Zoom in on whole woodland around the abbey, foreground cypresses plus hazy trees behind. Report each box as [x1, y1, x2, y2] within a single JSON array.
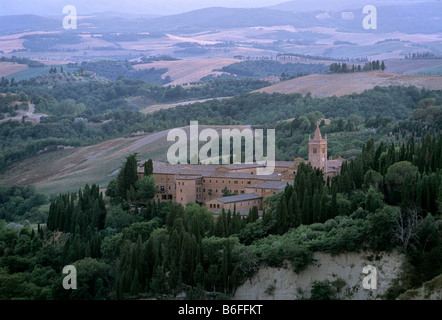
[[0, 69, 442, 300]]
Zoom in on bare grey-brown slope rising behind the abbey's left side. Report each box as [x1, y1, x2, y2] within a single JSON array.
[[0, 126, 249, 195]]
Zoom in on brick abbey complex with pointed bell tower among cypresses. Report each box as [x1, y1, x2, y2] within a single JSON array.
[[138, 126, 344, 215]]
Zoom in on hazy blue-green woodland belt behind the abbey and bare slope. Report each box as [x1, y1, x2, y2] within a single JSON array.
[[0, 83, 442, 170]]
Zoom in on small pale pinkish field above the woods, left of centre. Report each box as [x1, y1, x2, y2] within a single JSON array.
[[134, 58, 240, 85]]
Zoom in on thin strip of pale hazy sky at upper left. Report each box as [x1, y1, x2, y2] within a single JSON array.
[[0, 0, 287, 15]]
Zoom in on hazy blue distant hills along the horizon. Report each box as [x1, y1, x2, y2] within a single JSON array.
[[0, 0, 442, 34]]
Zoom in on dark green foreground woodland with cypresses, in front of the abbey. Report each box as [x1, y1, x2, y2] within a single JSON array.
[[0, 120, 442, 299]]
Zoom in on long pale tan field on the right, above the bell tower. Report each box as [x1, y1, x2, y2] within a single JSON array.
[[257, 72, 442, 98]]
